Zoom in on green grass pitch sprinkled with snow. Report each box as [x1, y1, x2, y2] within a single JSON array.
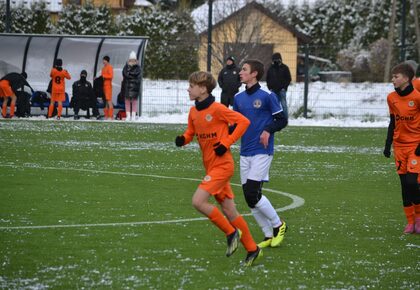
[[0, 120, 420, 289]]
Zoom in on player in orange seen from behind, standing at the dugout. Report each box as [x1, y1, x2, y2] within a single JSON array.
[[48, 58, 71, 120]]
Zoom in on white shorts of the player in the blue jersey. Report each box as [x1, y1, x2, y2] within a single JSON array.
[[240, 154, 273, 184]]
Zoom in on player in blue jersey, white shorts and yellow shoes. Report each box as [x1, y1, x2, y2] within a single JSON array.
[[233, 60, 287, 248]]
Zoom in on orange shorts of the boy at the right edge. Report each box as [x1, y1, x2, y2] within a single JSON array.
[[394, 145, 420, 174]]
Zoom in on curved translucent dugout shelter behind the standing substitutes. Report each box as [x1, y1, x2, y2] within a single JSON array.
[[0, 33, 148, 113]]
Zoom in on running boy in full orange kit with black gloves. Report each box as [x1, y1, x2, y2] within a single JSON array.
[[175, 71, 262, 266]]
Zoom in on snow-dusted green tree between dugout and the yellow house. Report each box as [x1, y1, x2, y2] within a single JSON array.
[[117, 9, 198, 79]]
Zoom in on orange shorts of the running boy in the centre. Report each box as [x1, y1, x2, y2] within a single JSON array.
[[198, 167, 235, 203]]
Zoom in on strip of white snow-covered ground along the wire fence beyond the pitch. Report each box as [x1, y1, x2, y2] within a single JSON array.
[[24, 79, 393, 127]]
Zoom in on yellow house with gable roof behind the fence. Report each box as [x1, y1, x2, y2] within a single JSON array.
[[192, 1, 310, 81]]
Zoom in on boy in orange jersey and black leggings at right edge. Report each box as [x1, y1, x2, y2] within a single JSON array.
[[384, 63, 420, 234]]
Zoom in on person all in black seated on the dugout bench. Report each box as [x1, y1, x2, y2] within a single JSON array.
[[70, 70, 100, 120]]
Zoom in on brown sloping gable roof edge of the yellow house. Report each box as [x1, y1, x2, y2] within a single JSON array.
[[195, 1, 311, 43]]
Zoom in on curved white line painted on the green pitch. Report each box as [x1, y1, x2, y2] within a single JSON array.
[[0, 164, 305, 230]]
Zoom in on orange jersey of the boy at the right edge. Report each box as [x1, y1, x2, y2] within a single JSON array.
[[387, 90, 420, 147]]
